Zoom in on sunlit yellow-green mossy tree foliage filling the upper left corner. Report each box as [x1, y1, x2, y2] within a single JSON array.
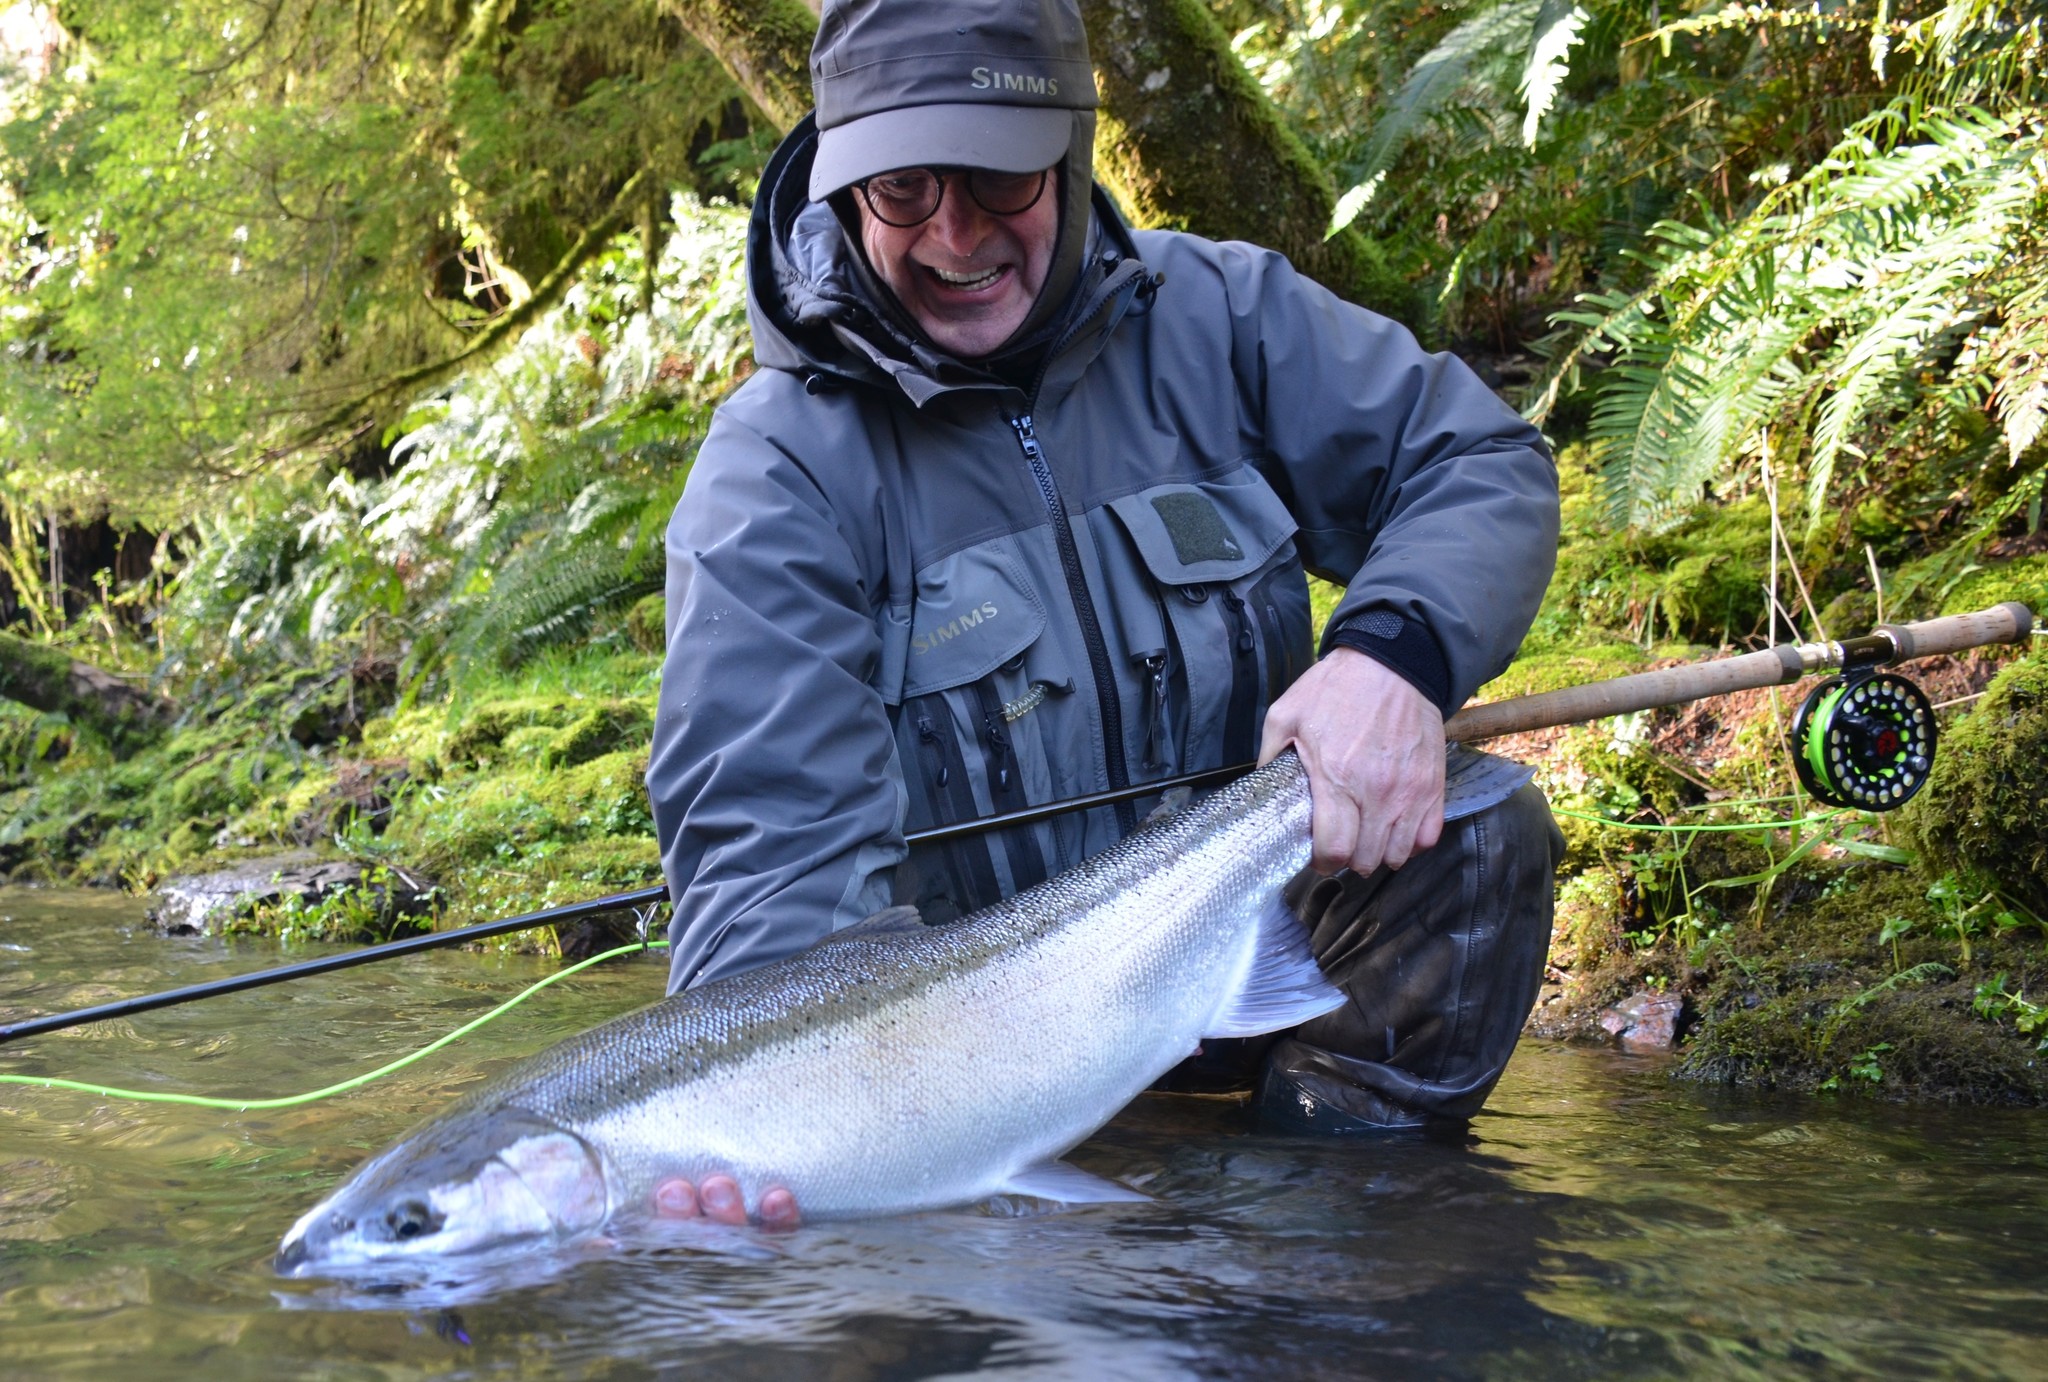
[[0, 0, 743, 516]]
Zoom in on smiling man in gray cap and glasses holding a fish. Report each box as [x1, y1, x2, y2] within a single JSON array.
[[647, 0, 1559, 1222]]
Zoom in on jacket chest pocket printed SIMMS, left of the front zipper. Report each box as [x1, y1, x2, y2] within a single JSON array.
[[879, 538, 1077, 923]]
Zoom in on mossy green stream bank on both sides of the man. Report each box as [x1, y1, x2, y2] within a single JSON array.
[[0, 448, 2048, 1104]]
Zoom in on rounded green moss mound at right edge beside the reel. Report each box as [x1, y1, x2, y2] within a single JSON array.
[[1905, 653, 2048, 917]]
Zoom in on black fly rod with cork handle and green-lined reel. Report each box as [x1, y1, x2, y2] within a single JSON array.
[[0, 604, 2034, 1044]]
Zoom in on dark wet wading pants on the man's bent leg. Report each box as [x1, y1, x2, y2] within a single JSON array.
[[1161, 786, 1565, 1134]]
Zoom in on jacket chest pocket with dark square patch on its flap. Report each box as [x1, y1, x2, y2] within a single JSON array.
[[1108, 467, 1313, 770]]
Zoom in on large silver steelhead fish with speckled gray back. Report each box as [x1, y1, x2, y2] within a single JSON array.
[[276, 753, 1343, 1276]]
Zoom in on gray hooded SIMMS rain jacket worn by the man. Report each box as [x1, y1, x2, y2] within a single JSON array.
[[647, 123, 1556, 989]]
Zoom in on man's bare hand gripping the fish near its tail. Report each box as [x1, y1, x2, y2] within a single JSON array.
[[1260, 647, 1444, 874]]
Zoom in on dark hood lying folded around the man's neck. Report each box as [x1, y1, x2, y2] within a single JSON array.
[[748, 115, 1145, 405]]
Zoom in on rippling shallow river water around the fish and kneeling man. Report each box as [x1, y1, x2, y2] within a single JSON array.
[[0, 891, 2048, 1382]]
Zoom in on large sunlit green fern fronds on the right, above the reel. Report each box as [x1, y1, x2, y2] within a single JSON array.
[[1532, 47, 2048, 524]]
